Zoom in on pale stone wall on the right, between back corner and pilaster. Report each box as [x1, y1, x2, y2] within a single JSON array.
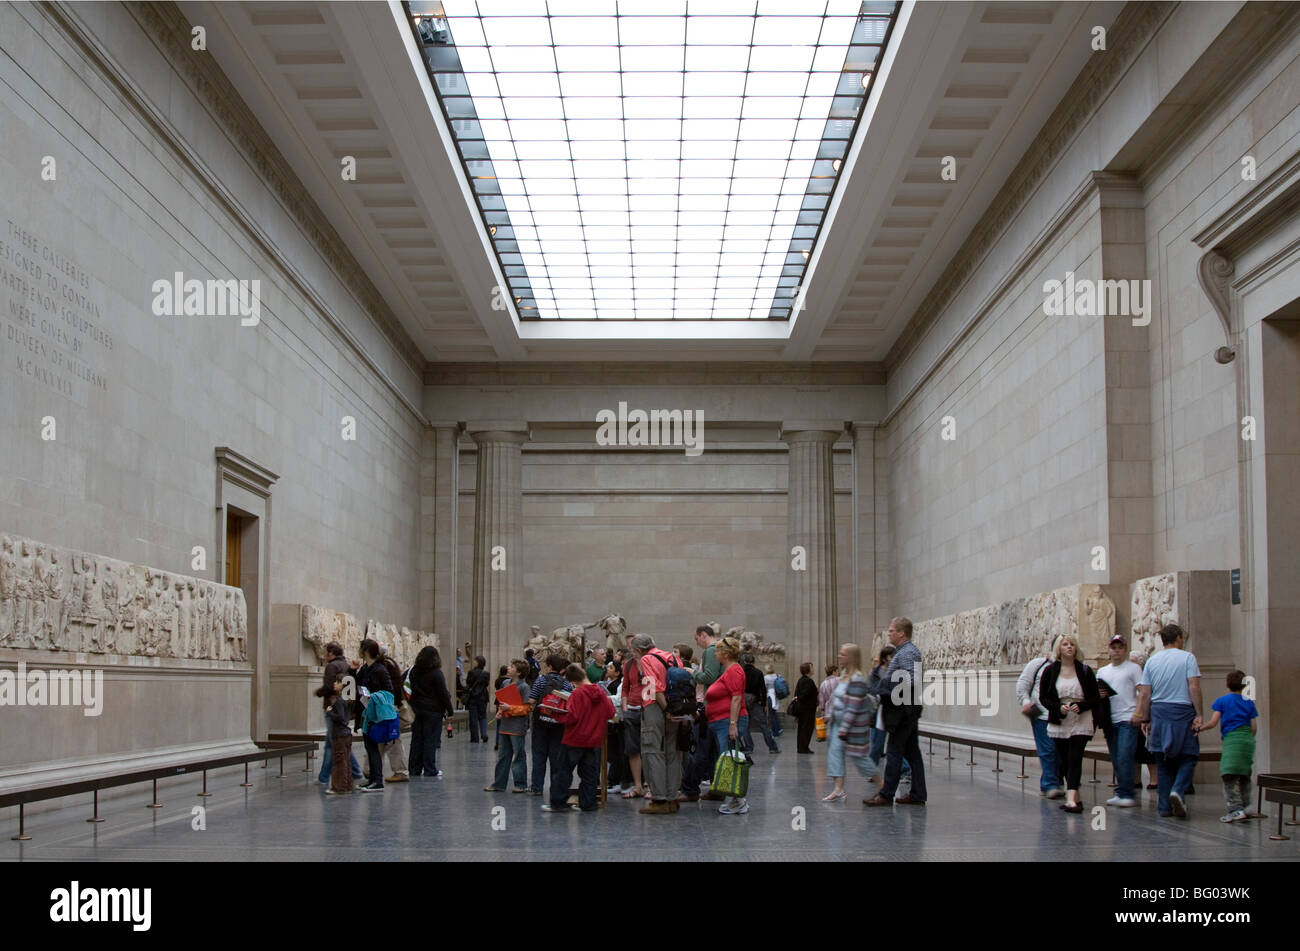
[[885, 208, 1106, 618]]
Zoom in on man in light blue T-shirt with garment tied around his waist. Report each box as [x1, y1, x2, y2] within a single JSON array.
[[1131, 624, 1201, 818]]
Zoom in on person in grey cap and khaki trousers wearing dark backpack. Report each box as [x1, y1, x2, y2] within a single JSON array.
[[632, 634, 696, 816]]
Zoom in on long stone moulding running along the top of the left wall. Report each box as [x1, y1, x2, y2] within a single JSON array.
[[40, 0, 428, 425]]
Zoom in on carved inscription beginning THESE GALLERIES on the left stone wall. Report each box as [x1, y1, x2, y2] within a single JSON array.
[[0, 220, 113, 401]]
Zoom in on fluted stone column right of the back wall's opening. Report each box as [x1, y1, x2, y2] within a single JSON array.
[[781, 422, 844, 670]]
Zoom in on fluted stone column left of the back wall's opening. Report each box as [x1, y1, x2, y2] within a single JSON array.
[[467, 422, 528, 670]]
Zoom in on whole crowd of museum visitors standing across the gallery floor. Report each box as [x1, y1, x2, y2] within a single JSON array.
[[317, 617, 1258, 822]]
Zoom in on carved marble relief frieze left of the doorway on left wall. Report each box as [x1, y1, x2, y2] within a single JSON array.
[[0, 535, 248, 661]]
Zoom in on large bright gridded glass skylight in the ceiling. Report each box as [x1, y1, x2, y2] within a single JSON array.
[[408, 0, 898, 320]]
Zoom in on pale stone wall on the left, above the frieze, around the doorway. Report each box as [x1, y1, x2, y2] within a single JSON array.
[[0, 4, 420, 626]]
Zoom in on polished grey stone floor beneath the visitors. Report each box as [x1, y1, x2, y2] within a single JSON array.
[[0, 734, 1300, 861]]
